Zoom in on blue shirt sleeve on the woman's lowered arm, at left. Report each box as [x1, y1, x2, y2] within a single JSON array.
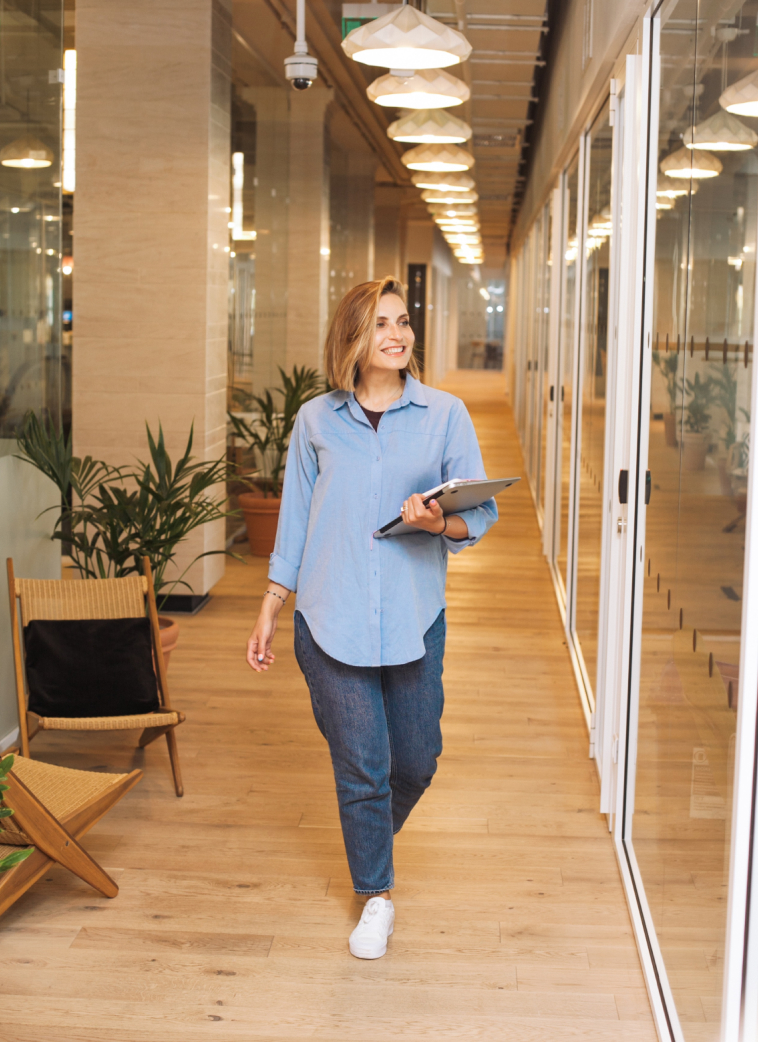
[[268, 415, 318, 590]]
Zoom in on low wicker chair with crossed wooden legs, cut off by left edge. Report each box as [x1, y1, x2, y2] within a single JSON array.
[[0, 756, 142, 914]]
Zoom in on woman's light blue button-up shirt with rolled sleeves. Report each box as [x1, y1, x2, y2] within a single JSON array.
[[268, 376, 497, 666]]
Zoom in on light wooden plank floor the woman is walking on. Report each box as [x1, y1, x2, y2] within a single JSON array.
[[0, 373, 656, 1042]]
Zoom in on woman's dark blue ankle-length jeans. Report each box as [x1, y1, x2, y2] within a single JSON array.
[[295, 611, 445, 894]]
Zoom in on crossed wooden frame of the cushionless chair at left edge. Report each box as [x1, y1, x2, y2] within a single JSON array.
[[0, 768, 143, 915]]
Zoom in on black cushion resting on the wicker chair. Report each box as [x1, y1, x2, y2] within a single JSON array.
[[24, 619, 161, 717]]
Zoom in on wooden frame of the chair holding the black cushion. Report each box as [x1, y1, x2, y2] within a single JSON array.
[[6, 557, 185, 796]]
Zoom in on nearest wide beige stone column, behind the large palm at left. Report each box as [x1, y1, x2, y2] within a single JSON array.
[[73, 0, 231, 594]]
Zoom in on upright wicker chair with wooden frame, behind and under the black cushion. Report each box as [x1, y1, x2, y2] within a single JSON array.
[[7, 557, 185, 796]]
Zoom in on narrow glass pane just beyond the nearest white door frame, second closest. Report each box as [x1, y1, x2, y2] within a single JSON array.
[[574, 106, 613, 686]]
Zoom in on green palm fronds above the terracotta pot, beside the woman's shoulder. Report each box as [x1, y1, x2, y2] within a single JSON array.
[[227, 366, 327, 498]]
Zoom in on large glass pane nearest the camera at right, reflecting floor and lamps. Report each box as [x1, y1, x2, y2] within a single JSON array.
[[634, 0, 758, 1042]]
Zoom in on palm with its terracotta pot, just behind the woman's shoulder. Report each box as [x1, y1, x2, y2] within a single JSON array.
[[228, 366, 326, 557]]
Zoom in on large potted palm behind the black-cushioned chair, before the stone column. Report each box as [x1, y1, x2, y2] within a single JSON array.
[[17, 413, 235, 665]]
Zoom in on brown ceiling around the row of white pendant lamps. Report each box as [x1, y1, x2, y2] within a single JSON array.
[[234, 0, 546, 268]]
